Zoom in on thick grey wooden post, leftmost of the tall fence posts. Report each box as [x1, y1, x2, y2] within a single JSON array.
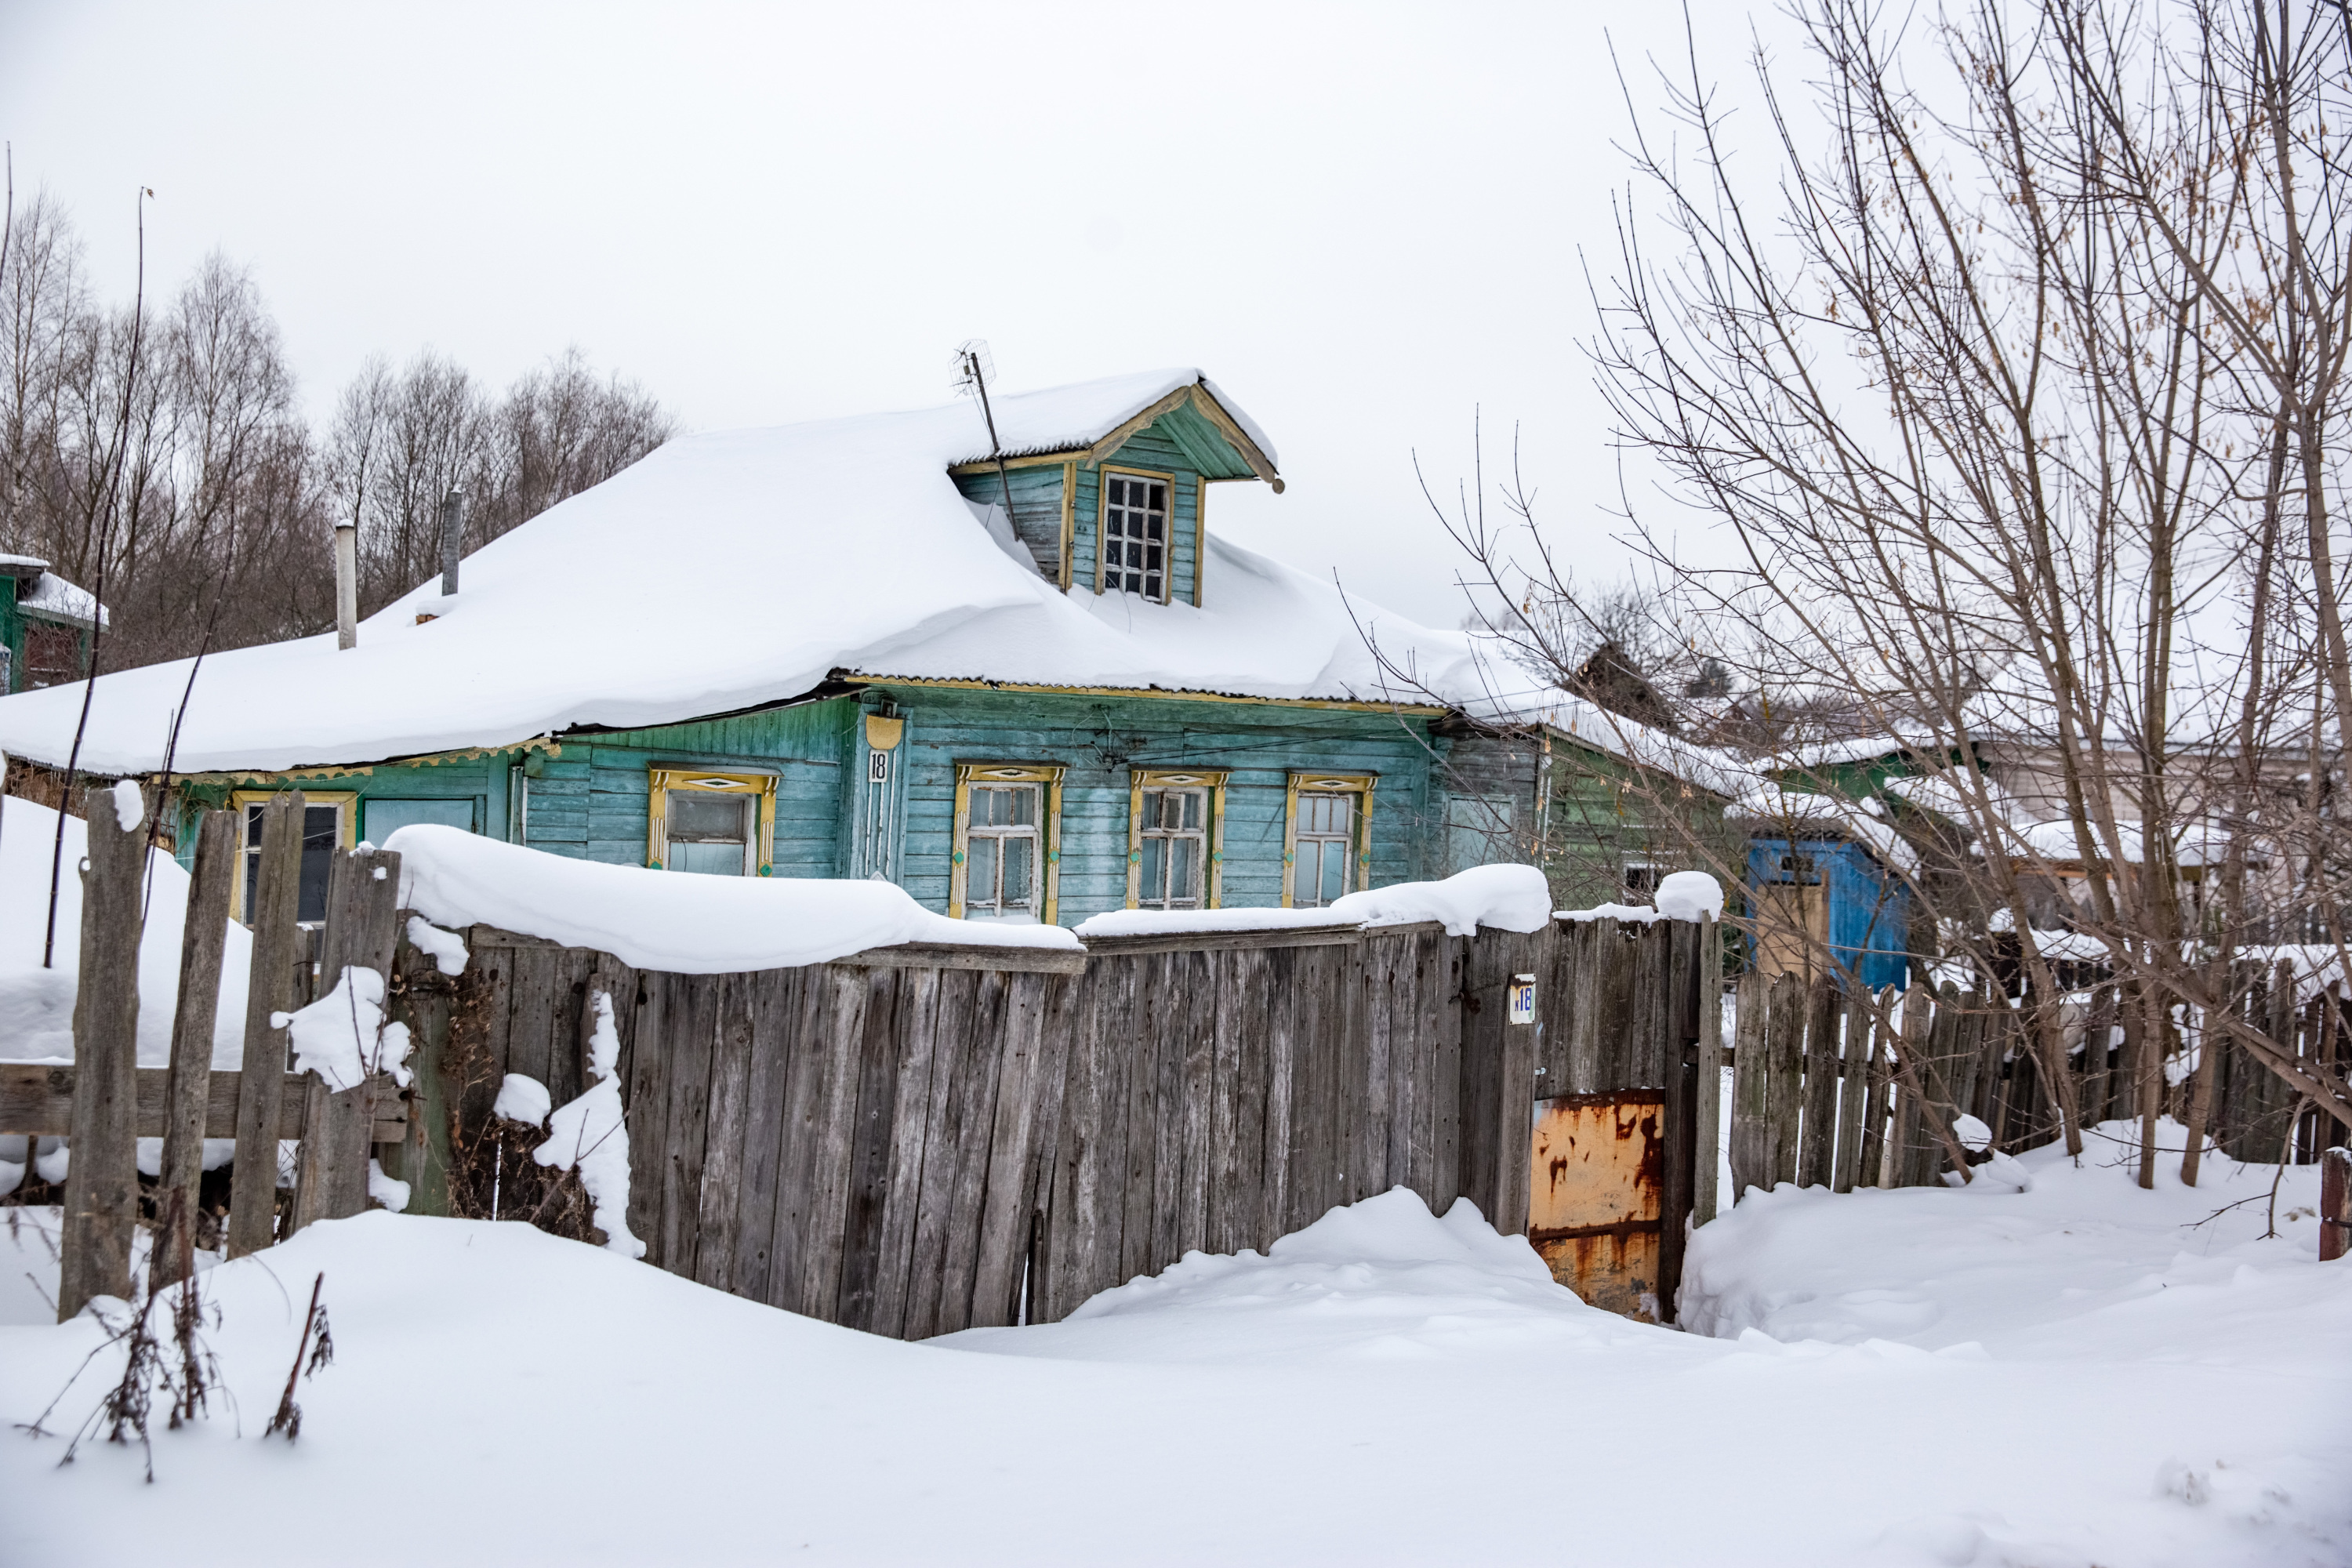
[[56, 787, 146, 1323]]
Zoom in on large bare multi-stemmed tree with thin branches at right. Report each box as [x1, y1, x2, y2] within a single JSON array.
[[1392, 0, 2352, 1182]]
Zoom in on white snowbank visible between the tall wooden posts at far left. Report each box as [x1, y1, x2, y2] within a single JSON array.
[[0, 794, 254, 1069]]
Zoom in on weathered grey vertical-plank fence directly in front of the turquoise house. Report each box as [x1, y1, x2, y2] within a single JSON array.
[[395, 921, 1712, 1338]]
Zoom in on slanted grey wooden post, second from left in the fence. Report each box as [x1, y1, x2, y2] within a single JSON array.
[[148, 811, 238, 1290]]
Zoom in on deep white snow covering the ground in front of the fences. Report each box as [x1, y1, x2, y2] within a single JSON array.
[[0, 1123, 2352, 1568]]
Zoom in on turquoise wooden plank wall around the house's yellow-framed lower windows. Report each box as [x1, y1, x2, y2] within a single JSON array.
[[170, 687, 1444, 924]]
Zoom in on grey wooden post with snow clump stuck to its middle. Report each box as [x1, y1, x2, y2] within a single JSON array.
[[287, 848, 400, 1234]]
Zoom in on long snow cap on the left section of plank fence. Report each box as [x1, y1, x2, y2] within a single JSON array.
[[383, 822, 1077, 975]]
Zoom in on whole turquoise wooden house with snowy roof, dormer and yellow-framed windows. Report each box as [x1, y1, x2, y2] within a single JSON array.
[[0, 372, 1541, 926]]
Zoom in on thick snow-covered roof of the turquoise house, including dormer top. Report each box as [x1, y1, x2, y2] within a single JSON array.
[[0, 369, 1479, 774]]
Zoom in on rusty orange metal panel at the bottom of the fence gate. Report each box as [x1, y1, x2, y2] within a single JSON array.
[[1526, 1091, 1665, 1319]]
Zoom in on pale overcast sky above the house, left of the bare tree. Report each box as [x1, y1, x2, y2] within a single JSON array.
[[0, 0, 1762, 623]]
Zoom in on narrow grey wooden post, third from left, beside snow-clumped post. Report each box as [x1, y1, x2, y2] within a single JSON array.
[[228, 789, 308, 1258]]
